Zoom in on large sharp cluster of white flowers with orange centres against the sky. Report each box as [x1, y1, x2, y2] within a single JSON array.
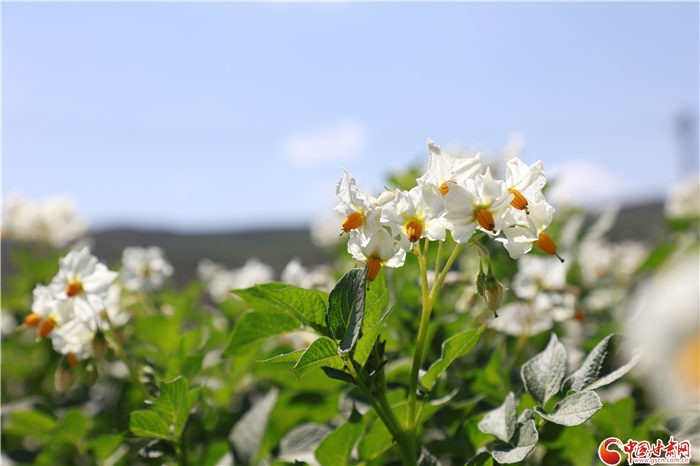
[[335, 140, 561, 281]]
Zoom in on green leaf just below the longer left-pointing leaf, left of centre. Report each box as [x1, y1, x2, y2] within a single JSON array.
[[222, 309, 299, 356]]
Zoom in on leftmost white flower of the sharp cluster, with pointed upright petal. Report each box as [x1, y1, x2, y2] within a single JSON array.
[[335, 168, 381, 235]]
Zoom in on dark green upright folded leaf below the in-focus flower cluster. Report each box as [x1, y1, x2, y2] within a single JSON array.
[[328, 267, 367, 353]]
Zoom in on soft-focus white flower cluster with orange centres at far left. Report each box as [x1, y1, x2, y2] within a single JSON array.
[[24, 247, 121, 363]]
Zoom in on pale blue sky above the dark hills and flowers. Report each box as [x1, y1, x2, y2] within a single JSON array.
[[2, 3, 700, 231]]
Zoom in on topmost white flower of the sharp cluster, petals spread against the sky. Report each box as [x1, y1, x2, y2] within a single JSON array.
[[416, 139, 481, 196]]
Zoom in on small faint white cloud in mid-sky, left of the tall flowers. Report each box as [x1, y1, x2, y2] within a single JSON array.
[[282, 121, 367, 165]]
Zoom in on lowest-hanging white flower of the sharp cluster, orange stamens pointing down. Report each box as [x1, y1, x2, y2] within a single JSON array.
[[348, 228, 409, 282]]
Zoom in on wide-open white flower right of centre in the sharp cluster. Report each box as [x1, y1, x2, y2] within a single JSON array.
[[445, 168, 513, 243]]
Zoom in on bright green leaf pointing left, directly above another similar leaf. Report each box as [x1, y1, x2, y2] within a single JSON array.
[[233, 283, 329, 335]]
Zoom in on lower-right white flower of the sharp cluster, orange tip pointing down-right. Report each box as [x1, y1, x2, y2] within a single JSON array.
[[496, 202, 557, 259]]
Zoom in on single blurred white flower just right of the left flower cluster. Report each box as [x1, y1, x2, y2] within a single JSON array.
[[121, 246, 173, 291]]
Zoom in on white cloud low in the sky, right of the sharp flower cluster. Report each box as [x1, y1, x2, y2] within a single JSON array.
[[546, 160, 629, 206]]
